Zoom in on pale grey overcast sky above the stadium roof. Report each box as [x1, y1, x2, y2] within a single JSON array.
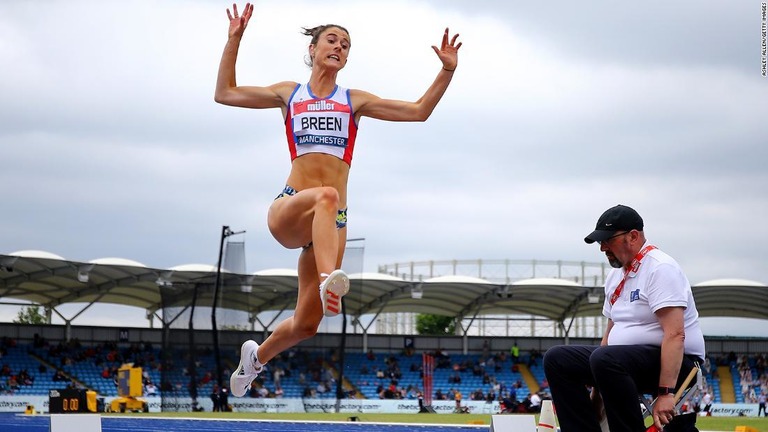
[[0, 0, 768, 336]]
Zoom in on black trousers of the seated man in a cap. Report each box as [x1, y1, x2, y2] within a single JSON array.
[[544, 345, 699, 432]]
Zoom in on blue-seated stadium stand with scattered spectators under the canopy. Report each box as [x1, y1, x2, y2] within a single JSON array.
[[9, 330, 768, 416]]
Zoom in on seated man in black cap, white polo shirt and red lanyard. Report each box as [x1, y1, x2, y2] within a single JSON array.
[[544, 205, 705, 432]]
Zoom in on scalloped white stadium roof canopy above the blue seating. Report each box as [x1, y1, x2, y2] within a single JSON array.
[[0, 251, 768, 325]]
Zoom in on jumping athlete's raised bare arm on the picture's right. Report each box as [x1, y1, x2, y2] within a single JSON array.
[[352, 28, 461, 121]]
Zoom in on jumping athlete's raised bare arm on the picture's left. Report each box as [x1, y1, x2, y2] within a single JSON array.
[[213, 3, 296, 108]]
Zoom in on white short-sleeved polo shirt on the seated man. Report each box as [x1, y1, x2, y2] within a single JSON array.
[[603, 243, 705, 359]]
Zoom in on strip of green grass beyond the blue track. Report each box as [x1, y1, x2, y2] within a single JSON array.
[[104, 412, 768, 432]]
